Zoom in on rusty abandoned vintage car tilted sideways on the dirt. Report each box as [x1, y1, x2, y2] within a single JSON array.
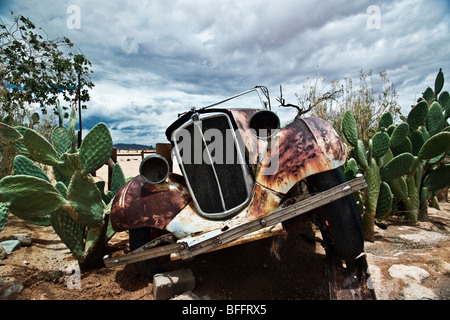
[[104, 86, 371, 295]]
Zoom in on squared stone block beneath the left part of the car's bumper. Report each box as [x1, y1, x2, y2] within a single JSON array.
[[153, 269, 195, 300]]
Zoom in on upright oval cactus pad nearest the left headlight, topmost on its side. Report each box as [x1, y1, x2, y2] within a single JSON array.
[[79, 123, 113, 173]]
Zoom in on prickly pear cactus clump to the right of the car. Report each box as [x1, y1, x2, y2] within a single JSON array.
[[342, 69, 450, 228]]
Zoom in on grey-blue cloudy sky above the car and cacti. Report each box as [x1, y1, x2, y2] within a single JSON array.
[[0, 0, 450, 144]]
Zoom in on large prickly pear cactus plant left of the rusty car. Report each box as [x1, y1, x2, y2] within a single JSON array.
[[0, 101, 126, 267]]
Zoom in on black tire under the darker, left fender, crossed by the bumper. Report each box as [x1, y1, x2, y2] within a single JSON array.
[[129, 228, 166, 277]]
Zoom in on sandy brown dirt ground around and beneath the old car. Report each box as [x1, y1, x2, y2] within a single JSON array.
[[0, 159, 450, 300]]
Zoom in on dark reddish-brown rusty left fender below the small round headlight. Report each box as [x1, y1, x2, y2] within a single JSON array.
[[111, 173, 191, 231]]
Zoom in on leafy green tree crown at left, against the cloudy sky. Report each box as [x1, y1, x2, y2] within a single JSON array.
[[0, 12, 94, 123]]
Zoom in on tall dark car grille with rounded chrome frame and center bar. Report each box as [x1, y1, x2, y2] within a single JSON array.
[[172, 113, 252, 219]]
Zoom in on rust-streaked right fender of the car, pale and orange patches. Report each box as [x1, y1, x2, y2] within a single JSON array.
[[256, 118, 347, 194]]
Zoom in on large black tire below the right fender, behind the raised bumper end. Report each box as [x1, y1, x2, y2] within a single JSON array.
[[306, 169, 364, 259]]
